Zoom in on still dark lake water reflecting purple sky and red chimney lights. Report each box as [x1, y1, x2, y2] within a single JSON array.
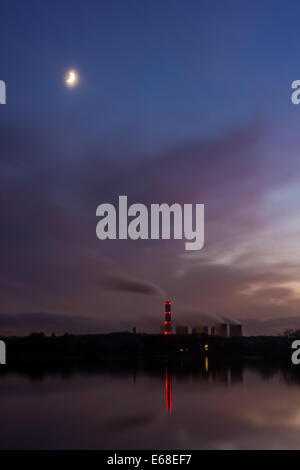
[[0, 358, 300, 449]]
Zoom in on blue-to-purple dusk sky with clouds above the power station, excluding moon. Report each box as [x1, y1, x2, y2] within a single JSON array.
[[0, 0, 300, 334]]
